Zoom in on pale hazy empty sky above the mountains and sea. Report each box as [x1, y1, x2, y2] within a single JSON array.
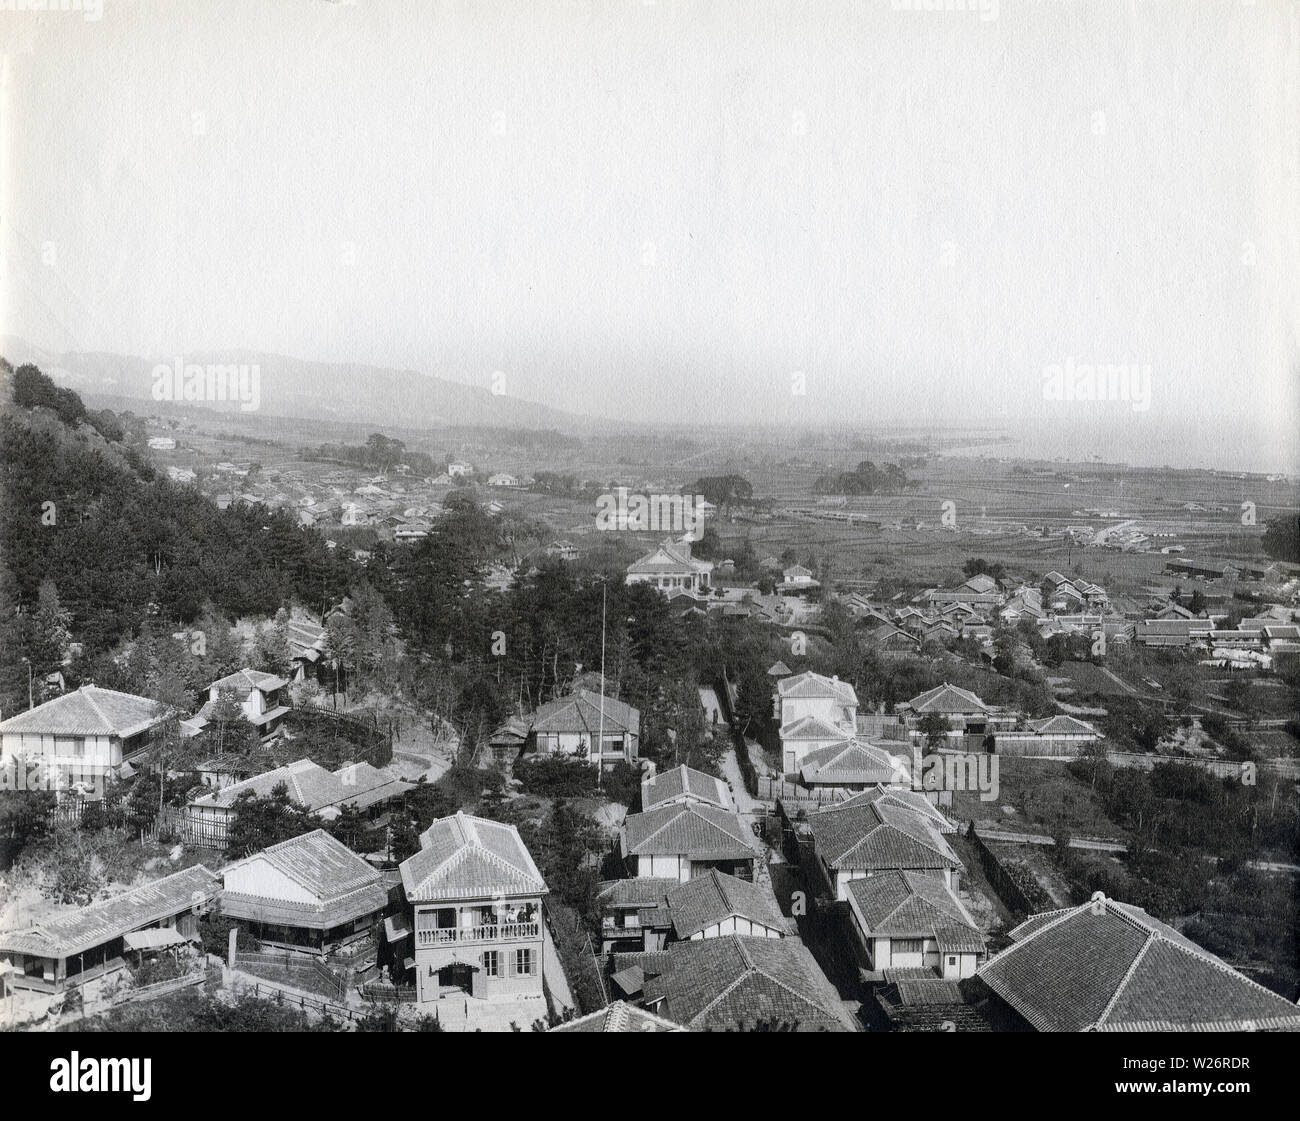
[[0, 0, 1300, 463]]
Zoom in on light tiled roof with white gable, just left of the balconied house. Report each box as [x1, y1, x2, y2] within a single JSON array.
[[221, 830, 389, 929]]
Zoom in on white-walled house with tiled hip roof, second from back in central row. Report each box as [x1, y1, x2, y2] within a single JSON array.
[[620, 802, 754, 883]]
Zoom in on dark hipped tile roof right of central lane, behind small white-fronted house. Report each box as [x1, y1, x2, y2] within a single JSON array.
[[809, 800, 962, 871]]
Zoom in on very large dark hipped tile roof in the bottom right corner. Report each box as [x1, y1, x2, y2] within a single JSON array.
[[978, 896, 1300, 1031]]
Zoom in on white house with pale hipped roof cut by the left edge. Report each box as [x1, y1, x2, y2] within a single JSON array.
[[0, 685, 174, 798]]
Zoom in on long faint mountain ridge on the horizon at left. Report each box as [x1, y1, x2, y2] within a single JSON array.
[[0, 336, 593, 432]]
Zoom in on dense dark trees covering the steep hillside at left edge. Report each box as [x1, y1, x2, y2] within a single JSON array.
[[0, 367, 356, 711]]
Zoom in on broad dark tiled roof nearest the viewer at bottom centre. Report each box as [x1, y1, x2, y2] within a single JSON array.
[[642, 935, 853, 1031]]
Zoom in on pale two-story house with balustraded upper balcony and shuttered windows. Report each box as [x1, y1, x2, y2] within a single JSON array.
[[402, 813, 547, 1004]]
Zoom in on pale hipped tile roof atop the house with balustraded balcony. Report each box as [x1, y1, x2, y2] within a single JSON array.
[[402, 813, 547, 900]]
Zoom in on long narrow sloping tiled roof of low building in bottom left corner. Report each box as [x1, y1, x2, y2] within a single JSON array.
[[0, 865, 221, 957]]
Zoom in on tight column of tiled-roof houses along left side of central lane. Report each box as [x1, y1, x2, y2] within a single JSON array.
[[592, 767, 854, 1031]]
